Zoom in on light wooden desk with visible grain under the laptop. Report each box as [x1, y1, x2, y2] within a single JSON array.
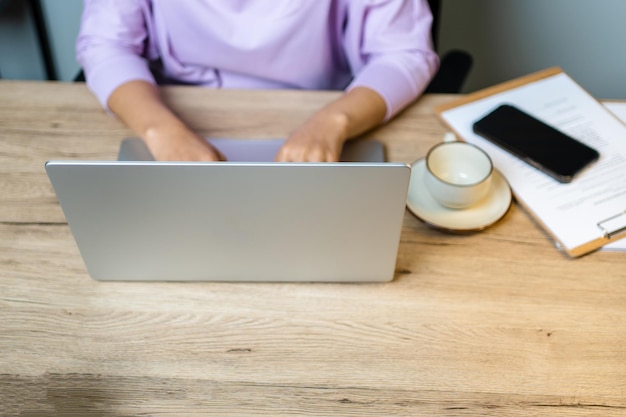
[[0, 81, 626, 417]]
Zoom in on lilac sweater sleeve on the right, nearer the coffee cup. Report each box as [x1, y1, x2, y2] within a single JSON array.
[[344, 0, 439, 121]]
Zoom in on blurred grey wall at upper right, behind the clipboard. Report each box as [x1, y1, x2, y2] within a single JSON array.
[[439, 0, 626, 99]]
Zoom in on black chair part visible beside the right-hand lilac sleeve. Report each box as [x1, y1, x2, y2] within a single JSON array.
[[425, 0, 473, 94]]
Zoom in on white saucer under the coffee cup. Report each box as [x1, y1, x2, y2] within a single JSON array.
[[407, 159, 512, 233]]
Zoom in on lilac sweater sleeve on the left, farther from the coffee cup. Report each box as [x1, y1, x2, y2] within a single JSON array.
[[76, 0, 155, 109]]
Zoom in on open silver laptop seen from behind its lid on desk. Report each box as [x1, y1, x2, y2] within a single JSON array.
[[45, 138, 410, 282]]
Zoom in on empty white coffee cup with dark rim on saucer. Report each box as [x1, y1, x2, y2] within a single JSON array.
[[424, 142, 493, 209]]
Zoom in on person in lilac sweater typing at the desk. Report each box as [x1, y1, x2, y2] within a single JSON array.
[[77, 0, 439, 161]]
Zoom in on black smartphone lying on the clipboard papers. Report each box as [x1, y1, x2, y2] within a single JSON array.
[[473, 104, 600, 183]]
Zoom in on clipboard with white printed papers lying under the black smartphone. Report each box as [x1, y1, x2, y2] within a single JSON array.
[[435, 68, 626, 257]]
